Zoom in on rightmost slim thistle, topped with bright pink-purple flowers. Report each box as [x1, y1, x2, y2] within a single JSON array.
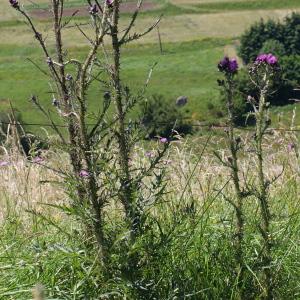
[[248, 54, 280, 299]]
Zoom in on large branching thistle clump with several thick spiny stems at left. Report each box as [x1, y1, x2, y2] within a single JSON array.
[[9, 0, 166, 263]]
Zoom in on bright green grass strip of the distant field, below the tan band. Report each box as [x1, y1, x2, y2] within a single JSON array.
[[0, 39, 232, 134]]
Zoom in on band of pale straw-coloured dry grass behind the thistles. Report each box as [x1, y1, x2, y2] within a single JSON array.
[[0, 131, 299, 221]]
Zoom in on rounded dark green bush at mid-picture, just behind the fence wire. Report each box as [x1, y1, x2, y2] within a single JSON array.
[[141, 95, 192, 139]]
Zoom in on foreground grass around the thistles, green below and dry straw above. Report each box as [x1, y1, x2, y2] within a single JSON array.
[[0, 132, 300, 300]]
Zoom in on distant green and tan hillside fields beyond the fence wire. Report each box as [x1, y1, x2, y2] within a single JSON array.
[[0, 0, 300, 132]]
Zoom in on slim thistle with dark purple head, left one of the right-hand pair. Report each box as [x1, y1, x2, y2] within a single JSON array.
[[215, 56, 247, 299]]
